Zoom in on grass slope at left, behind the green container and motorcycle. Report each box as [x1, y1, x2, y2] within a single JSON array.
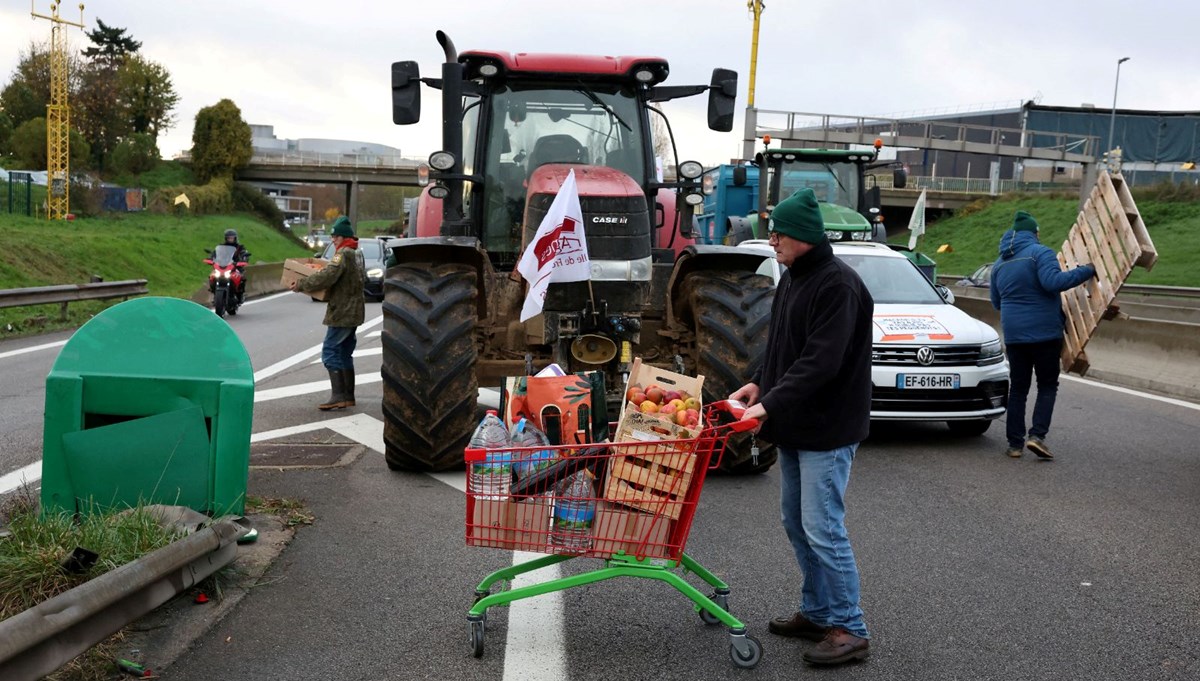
[[0, 212, 311, 338]]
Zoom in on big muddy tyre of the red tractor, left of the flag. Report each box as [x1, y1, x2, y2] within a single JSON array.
[[383, 263, 479, 472]]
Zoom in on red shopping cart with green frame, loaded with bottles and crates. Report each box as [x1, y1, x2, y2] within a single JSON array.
[[464, 402, 762, 669]]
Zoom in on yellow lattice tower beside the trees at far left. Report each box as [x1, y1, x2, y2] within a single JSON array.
[[29, 0, 84, 219]]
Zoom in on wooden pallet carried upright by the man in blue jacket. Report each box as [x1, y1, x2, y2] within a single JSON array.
[[1058, 170, 1158, 375]]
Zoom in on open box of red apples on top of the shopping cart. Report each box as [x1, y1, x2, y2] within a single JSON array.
[[618, 357, 704, 438]]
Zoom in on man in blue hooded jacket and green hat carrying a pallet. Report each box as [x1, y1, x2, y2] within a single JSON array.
[[991, 211, 1096, 460]]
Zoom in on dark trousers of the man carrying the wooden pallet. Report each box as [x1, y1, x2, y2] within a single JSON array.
[[1004, 338, 1062, 450]]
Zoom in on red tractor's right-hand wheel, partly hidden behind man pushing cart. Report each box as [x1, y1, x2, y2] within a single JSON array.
[[683, 271, 776, 475]]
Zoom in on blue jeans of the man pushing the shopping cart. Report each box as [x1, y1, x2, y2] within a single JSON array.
[[778, 442, 870, 638]]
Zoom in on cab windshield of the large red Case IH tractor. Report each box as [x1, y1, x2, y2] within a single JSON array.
[[482, 80, 646, 253]]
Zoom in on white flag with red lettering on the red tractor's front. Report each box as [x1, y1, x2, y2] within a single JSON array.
[[517, 170, 592, 321]]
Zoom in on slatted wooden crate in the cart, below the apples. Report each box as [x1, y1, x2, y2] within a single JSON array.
[[604, 429, 696, 520]]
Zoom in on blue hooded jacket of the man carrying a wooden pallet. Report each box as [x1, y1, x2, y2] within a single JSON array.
[[991, 229, 1096, 343]]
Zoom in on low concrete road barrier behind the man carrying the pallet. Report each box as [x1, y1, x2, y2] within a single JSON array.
[[954, 296, 1200, 402]]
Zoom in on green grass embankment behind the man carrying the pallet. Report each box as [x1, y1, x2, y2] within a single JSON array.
[[892, 193, 1200, 287]]
